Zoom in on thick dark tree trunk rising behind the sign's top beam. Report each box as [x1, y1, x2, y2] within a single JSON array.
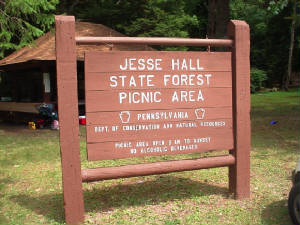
[[207, 0, 230, 38]]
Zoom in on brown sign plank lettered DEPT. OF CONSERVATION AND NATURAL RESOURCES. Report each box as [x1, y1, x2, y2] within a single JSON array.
[[86, 119, 232, 143]]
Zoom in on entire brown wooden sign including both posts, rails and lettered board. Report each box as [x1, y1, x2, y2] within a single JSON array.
[[55, 16, 250, 224]]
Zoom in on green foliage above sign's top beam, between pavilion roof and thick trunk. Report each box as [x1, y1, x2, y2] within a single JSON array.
[[73, 0, 199, 50]]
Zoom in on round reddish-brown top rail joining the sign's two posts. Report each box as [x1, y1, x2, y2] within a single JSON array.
[[75, 37, 233, 47]]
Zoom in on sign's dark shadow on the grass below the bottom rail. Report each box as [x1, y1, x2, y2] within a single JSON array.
[[11, 175, 229, 223]]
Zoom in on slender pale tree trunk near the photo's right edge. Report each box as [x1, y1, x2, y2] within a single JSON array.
[[283, 1, 297, 91]]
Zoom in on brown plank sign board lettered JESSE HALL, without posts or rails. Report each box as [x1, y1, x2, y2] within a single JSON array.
[[85, 51, 233, 160]]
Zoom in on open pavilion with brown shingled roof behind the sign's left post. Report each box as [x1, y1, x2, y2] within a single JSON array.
[[0, 22, 153, 120]]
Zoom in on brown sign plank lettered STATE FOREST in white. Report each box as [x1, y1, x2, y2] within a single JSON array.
[[85, 71, 232, 91]]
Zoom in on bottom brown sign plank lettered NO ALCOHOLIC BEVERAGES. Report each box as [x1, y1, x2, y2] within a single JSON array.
[[87, 134, 233, 161]]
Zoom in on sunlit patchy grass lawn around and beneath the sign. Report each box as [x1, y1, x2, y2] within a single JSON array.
[[0, 89, 300, 225]]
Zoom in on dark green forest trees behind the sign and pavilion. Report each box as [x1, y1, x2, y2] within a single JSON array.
[[0, 0, 300, 92]]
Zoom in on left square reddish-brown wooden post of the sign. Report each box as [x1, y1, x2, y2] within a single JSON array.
[[55, 16, 84, 224]]
